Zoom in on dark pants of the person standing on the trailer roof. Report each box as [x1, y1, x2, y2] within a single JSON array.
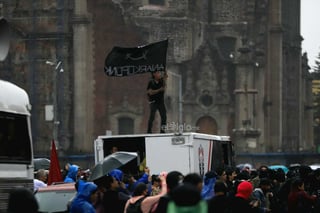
[[148, 102, 167, 133]]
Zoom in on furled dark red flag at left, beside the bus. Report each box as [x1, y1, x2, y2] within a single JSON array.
[[48, 140, 63, 185]]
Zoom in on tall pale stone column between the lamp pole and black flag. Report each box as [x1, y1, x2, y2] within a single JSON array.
[[72, 0, 94, 152]]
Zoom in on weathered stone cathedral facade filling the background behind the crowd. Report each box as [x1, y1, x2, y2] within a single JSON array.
[[0, 0, 315, 166]]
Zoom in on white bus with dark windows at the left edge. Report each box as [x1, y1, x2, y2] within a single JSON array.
[[0, 79, 34, 212]]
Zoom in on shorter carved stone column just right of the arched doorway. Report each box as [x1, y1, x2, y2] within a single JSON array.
[[233, 40, 260, 153]]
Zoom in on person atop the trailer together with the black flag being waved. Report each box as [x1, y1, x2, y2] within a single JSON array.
[[104, 39, 168, 133]]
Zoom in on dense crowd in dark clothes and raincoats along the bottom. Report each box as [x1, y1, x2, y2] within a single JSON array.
[[9, 162, 320, 213]]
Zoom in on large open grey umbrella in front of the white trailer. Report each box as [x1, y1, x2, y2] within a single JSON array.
[[90, 152, 138, 180]]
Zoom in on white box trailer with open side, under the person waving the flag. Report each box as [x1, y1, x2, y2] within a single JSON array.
[[94, 132, 234, 175]]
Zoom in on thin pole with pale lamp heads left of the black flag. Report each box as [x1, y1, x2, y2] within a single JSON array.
[[46, 60, 64, 149]]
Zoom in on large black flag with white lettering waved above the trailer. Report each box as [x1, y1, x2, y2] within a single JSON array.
[[104, 39, 168, 77]]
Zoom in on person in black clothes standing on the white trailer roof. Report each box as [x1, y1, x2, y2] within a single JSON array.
[[147, 71, 168, 133]]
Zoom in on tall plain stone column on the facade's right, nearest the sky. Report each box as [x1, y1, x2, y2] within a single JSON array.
[[265, 0, 283, 152]]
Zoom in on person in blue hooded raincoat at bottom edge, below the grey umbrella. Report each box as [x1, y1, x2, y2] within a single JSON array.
[[70, 181, 98, 213]]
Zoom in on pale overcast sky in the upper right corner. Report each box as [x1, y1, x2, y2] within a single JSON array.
[[301, 0, 320, 68]]
